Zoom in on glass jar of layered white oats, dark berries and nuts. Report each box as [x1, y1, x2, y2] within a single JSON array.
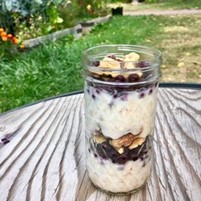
[[83, 45, 161, 194]]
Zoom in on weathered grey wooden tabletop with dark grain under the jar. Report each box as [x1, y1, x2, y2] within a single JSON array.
[[0, 84, 201, 201]]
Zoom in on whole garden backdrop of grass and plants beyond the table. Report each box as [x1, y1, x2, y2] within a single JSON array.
[[0, 0, 201, 112]]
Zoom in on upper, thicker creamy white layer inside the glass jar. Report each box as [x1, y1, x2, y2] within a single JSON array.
[[85, 86, 156, 139]]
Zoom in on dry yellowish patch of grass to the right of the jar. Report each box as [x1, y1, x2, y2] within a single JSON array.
[[156, 15, 201, 82]]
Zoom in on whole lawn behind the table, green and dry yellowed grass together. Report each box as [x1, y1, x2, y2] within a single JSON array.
[[0, 15, 201, 112]]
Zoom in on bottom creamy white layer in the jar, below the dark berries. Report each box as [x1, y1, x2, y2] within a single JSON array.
[[87, 153, 152, 193]]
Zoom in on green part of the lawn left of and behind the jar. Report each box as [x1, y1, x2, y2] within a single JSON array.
[[0, 17, 158, 112]]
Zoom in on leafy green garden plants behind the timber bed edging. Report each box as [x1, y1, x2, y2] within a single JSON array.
[[0, 0, 110, 40]]
